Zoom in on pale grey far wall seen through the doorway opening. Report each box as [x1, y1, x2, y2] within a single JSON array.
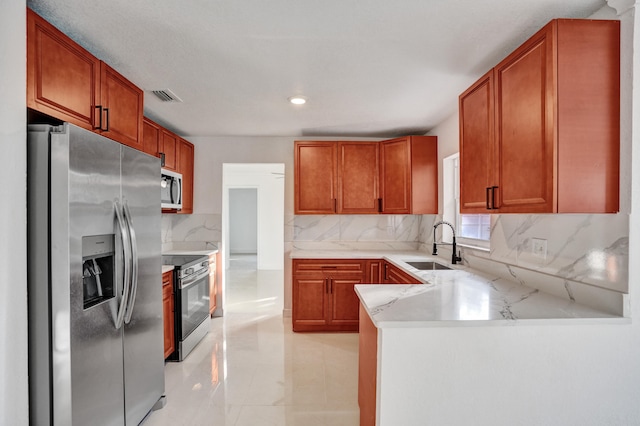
[[229, 188, 258, 254]]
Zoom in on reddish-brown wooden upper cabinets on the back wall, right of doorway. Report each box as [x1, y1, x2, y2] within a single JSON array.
[[294, 136, 438, 214]]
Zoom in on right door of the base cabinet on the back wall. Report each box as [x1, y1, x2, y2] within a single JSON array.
[[328, 274, 365, 331]]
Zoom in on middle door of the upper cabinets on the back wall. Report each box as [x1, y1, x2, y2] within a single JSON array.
[[337, 142, 380, 214]]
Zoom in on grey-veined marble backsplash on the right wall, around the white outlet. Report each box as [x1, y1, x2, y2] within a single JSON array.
[[420, 214, 629, 315]]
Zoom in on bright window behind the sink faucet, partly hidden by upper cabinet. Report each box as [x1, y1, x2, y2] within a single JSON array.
[[442, 154, 491, 249]]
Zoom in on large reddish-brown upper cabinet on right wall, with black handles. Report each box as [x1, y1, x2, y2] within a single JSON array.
[[459, 19, 620, 213]]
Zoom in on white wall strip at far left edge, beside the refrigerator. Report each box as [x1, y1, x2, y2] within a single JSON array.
[[0, 0, 29, 425]]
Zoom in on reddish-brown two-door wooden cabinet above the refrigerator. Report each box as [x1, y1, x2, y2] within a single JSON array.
[[27, 9, 143, 150]]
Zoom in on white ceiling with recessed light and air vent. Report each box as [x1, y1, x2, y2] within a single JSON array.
[[27, 0, 606, 137]]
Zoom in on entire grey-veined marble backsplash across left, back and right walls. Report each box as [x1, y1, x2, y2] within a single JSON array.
[[162, 210, 629, 305]]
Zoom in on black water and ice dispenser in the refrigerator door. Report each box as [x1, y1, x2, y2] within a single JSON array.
[[82, 234, 115, 309]]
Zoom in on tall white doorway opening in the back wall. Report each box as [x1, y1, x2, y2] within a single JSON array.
[[221, 164, 284, 313]]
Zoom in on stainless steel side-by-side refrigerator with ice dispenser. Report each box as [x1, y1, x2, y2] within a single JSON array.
[[27, 123, 164, 425]]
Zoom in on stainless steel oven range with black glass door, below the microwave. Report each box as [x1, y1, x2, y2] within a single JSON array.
[[162, 255, 210, 361]]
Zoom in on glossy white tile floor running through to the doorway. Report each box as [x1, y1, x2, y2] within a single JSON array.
[[145, 255, 359, 426]]
